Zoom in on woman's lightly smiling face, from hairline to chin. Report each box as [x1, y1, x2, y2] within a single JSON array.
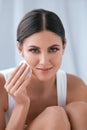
[[18, 31, 65, 81]]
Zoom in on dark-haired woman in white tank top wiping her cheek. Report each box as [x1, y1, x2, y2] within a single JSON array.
[[0, 9, 87, 130]]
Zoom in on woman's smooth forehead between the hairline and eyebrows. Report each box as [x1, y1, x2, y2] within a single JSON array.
[[24, 31, 62, 46]]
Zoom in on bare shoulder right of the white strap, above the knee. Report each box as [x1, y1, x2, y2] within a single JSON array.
[[67, 74, 87, 102]]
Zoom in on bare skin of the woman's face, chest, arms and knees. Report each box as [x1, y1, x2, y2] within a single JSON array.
[[0, 31, 87, 130]]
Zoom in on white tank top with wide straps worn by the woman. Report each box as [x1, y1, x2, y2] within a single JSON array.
[[0, 68, 67, 123]]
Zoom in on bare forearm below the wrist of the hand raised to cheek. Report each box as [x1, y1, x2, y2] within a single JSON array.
[[5, 103, 29, 130]]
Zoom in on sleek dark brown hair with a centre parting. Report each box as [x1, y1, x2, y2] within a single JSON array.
[[17, 9, 65, 45]]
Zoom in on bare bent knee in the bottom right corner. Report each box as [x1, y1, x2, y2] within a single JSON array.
[[65, 101, 87, 130]]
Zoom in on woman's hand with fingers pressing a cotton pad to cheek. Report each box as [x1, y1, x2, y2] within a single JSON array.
[[5, 63, 30, 105]]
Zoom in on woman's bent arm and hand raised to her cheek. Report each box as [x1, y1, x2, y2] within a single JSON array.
[[0, 64, 30, 130]]
